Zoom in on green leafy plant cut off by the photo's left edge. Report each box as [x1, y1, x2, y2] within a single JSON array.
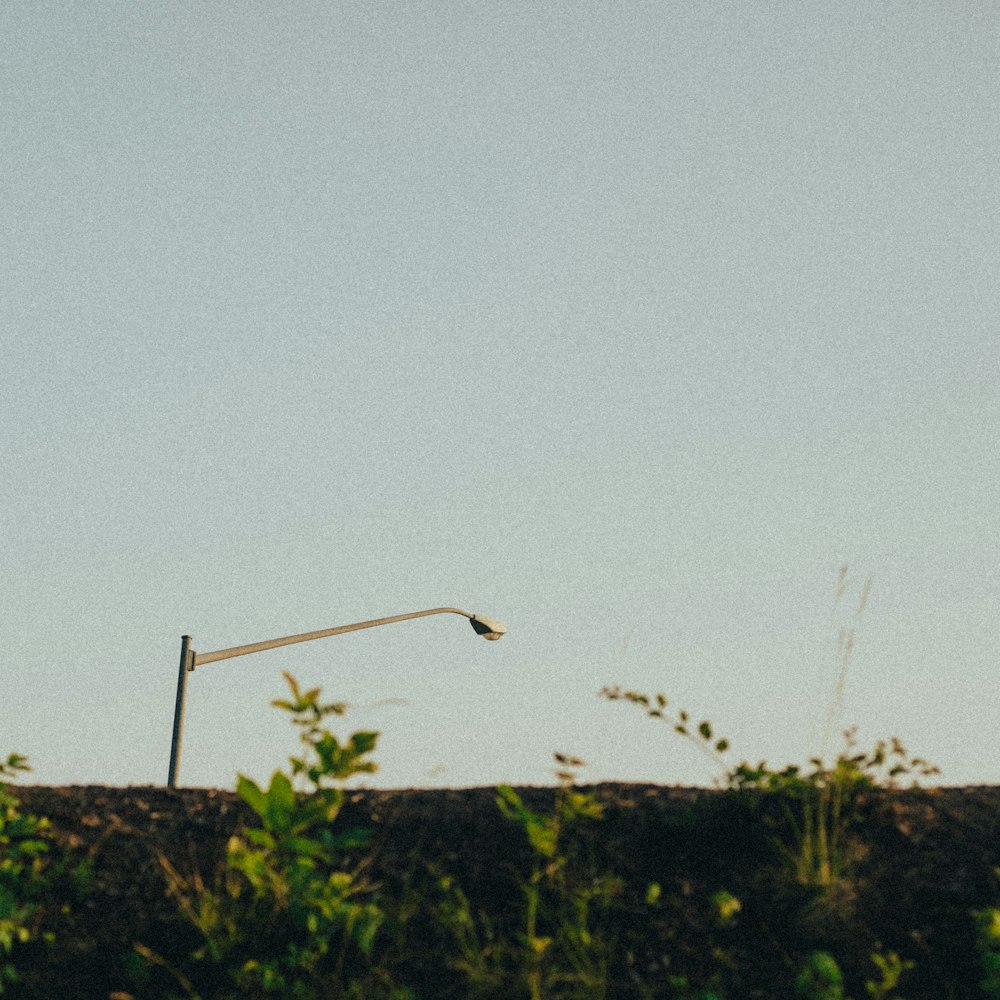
[[0, 754, 51, 993]]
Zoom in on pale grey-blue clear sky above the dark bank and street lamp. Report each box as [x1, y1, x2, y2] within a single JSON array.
[[0, 0, 1000, 788]]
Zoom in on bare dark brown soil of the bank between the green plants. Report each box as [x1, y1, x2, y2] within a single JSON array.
[[11, 784, 1000, 1000]]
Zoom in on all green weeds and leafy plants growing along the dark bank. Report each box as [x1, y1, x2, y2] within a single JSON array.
[[0, 644, 1000, 1000]]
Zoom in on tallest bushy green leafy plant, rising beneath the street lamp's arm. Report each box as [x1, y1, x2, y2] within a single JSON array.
[[156, 674, 392, 1000]]
